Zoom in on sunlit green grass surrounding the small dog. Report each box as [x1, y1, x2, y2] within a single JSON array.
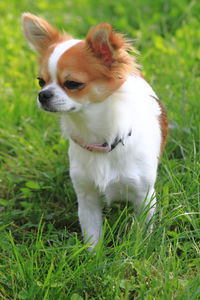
[[0, 0, 200, 300]]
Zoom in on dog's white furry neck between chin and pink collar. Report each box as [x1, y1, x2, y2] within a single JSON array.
[[61, 79, 132, 147]]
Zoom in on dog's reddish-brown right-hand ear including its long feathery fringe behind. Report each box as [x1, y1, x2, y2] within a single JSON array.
[[86, 23, 140, 78]]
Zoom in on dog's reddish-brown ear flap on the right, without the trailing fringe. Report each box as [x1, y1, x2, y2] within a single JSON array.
[[86, 23, 124, 68]]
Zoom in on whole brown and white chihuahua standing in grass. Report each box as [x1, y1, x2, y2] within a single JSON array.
[[22, 13, 168, 250]]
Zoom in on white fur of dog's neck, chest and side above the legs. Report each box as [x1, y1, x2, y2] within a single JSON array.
[[62, 76, 161, 191]]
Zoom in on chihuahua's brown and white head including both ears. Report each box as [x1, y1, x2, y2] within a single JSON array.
[[22, 13, 138, 112]]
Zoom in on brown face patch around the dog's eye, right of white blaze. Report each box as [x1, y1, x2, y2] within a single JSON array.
[[57, 41, 125, 102]]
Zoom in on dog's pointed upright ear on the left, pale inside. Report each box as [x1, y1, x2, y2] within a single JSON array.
[[22, 13, 59, 54]]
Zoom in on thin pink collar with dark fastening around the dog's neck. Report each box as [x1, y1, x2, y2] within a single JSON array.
[[71, 131, 132, 153]]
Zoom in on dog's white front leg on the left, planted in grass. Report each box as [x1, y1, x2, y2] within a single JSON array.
[[78, 192, 102, 251]]
